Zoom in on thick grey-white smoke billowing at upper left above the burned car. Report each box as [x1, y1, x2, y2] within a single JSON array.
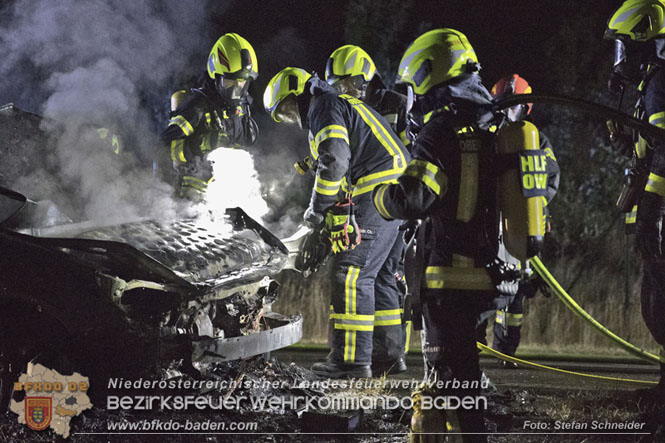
[[0, 0, 236, 220]]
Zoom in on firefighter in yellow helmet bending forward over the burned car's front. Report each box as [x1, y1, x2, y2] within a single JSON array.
[[263, 68, 410, 378]]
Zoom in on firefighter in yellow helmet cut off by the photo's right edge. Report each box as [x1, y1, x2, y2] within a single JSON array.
[[605, 0, 665, 399]]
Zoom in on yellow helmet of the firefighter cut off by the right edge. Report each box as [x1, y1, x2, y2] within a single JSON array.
[[605, 0, 665, 42]]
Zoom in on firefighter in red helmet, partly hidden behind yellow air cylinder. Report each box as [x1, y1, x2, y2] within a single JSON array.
[[478, 74, 561, 368]]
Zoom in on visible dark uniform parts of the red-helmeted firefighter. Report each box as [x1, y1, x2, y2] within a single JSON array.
[[478, 131, 561, 355]]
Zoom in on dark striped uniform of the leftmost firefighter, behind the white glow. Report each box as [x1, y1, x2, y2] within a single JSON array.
[[161, 78, 258, 198]]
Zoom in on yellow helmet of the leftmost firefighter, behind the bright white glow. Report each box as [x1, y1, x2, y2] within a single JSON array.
[[208, 34, 259, 80]]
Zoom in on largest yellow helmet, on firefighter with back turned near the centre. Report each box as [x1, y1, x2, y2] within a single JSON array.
[[397, 28, 480, 95]]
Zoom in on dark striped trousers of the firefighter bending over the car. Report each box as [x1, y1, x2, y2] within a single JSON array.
[[331, 195, 403, 365]]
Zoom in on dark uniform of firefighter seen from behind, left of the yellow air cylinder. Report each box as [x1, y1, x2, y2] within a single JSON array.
[[373, 75, 510, 438]]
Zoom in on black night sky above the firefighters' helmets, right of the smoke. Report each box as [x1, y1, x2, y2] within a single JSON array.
[[211, 0, 622, 102]]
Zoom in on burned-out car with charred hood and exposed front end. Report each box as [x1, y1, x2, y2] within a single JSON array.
[[0, 183, 302, 407]]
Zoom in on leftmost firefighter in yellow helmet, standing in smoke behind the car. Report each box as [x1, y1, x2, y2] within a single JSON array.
[[161, 34, 259, 200]]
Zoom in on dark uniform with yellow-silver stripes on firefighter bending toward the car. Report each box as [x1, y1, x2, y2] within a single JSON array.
[[307, 78, 410, 365]]
